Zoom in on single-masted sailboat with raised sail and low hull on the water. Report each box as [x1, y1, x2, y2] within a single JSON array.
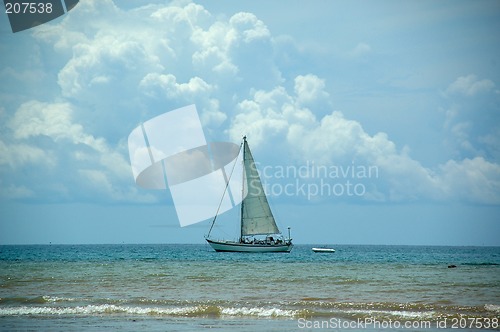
[[205, 136, 293, 252]]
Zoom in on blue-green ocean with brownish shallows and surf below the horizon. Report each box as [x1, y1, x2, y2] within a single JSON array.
[[0, 244, 500, 331]]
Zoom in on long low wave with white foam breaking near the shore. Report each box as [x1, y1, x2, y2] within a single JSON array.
[[0, 296, 500, 320]]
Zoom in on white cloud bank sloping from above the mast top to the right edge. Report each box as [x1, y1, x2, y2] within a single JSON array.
[[229, 77, 500, 204]]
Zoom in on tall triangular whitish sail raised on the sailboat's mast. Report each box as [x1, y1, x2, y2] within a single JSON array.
[[241, 140, 280, 236]]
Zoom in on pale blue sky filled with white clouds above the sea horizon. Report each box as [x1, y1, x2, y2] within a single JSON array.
[[0, 0, 500, 246]]
